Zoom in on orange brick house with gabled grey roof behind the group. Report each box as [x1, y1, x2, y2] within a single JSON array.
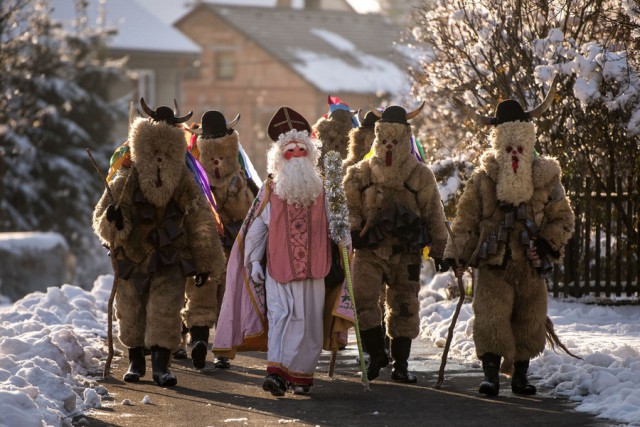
[[174, 0, 409, 174]]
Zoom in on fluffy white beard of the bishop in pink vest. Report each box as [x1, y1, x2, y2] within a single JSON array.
[[274, 157, 322, 207]]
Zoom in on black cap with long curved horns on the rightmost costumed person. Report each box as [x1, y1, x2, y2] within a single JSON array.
[[453, 74, 560, 126]]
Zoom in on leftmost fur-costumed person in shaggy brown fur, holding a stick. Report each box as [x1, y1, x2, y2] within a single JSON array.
[[93, 99, 224, 386]]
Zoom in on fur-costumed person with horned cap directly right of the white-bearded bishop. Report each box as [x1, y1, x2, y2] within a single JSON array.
[[344, 103, 447, 383]]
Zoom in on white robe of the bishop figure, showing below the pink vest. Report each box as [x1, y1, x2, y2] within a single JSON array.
[[244, 203, 325, 383]]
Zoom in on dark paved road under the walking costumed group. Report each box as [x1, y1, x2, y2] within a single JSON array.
[[80, 340, 616, 427]]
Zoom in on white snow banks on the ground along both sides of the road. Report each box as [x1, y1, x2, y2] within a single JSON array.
[[0, 273, 640, 427]]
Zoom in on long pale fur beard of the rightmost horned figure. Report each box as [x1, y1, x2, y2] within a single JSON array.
[[496, 154, 533, 205]]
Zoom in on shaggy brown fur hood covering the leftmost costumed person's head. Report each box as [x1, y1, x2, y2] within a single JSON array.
[[129, 118, 187, 206]]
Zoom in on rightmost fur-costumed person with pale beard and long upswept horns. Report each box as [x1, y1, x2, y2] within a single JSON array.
[[445, 74, 574, 396]]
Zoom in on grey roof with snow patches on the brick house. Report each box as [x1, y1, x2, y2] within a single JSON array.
[[182, 4, 409, 93]]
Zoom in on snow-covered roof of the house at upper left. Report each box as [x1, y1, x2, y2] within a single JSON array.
[[51, 0, 201, 55]]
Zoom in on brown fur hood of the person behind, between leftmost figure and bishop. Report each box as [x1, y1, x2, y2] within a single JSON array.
[[196, 131, 240, 182]]
